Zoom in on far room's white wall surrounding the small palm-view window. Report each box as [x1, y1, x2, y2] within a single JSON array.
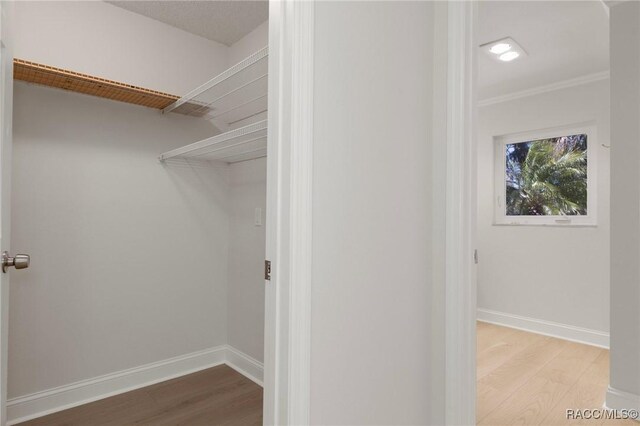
[[477, 80, 609, 332]]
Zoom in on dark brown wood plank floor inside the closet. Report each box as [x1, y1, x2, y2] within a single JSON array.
[[21, 365, 262, 426]]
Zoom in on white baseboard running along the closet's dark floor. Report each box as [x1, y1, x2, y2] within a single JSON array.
[[7, 345, 263, 425]]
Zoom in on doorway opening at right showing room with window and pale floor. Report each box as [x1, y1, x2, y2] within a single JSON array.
[[475, 1, 610, 425]]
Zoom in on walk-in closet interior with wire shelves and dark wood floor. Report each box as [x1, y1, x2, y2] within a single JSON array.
[[7, 1, 271, 424]]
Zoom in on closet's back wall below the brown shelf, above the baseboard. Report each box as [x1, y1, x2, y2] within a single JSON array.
[[9, 83, 229, 397]]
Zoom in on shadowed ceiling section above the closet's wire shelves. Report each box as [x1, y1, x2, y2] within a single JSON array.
[[107, 0, 269, 46]]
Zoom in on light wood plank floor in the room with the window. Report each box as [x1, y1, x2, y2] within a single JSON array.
[[476, 322, 638, 426]]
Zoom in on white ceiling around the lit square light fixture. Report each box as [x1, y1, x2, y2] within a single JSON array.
[[478, 1, 609, 100]]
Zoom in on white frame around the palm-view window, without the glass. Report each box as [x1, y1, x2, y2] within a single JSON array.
[[493, 122, 598, 226]]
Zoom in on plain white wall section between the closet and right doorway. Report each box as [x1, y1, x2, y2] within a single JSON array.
[[311, 2, 443, 425]]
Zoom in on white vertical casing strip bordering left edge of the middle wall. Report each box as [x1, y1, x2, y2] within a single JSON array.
[[288, 2, 315, 425]]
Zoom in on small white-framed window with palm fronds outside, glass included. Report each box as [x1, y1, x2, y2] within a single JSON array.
[[495, 125, 597, 225]]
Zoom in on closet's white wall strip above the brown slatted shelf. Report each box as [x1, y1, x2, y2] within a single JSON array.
[[14, 1, 229, 96]]
